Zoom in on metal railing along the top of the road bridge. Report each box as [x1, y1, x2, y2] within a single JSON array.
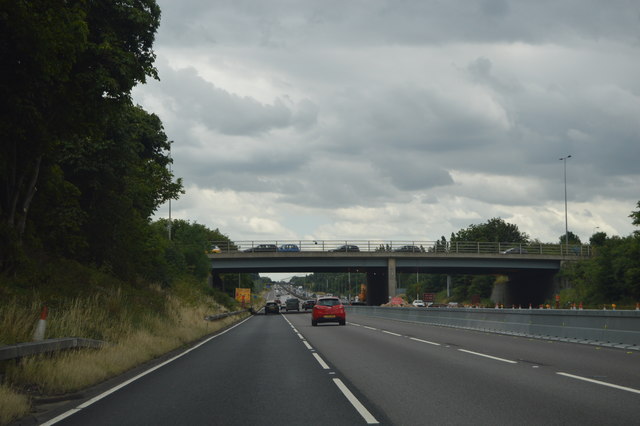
[[205, 240, 592, 257]]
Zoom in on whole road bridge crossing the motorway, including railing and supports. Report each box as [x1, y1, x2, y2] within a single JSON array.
[[209, 240, 591, 305]]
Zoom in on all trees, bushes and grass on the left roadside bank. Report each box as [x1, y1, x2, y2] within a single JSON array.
[[0, 0, 255, 424]]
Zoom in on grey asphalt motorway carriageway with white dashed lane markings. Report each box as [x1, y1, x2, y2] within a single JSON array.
[[37, 298, 640, 425]]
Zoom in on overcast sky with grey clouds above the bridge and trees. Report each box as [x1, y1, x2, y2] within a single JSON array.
[[134, 0, 640, 246]]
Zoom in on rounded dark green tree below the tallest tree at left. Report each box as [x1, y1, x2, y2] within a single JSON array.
[[31, 105, 182, 277]]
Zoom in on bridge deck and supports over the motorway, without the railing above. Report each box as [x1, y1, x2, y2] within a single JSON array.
[[209, 252, 563, 306]]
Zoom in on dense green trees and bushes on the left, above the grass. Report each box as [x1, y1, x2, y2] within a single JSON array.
[[0, 0, 253, 312]]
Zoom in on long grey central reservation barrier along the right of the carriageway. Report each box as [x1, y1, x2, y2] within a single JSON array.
[[346, 306, 640, 350]]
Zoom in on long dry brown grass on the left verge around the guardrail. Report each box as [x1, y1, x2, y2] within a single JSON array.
[[0, 288, 249, 425]]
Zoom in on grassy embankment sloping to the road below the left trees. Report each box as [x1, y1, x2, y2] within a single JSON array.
[[0, 258, 258, 425]]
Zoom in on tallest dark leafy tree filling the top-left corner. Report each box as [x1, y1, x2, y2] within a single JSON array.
[[0, 0, 160, 269]]
